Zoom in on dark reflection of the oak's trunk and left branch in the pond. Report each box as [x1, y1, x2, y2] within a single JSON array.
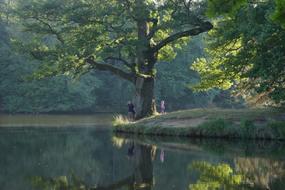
[[30, 145, 153, 190]]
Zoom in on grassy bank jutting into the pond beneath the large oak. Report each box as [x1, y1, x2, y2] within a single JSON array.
[[114, 109, 285, 140]]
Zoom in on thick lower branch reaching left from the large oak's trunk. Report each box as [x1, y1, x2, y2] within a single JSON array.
[[85, 56, 135, 82]]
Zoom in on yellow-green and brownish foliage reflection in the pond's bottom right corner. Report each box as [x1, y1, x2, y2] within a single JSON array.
[[189, 158, 285, 190]]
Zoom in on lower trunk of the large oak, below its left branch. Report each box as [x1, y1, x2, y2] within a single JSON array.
[[134, 77, 155, 119]]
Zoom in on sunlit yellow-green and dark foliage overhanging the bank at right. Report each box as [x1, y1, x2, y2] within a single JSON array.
[[193, 0, 285, 103]]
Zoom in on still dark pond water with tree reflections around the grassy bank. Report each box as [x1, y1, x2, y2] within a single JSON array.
[[0, 115, 285, 190]]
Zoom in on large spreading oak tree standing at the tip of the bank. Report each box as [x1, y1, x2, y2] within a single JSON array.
[[13, 0, 213, 118]]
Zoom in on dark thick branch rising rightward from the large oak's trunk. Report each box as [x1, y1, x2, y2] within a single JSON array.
[[152, 22, 213, 52]]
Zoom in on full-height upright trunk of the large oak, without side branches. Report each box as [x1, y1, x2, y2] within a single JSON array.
[[134, 0, 156, 119]]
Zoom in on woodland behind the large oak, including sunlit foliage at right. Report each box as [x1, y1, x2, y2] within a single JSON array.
[[0, 0, 285, 113]]
